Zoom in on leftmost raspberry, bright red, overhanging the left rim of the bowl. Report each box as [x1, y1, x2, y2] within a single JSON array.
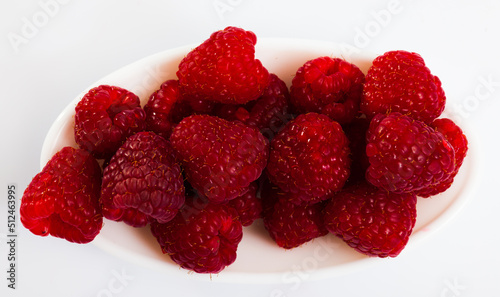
[[20, 147, 102, 243]]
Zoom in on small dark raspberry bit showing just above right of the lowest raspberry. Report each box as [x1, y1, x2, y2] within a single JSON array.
[[228, 182, 262, 227]]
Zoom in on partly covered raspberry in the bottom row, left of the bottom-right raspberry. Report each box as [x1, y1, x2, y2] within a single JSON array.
[[262, 177, 328, 249]]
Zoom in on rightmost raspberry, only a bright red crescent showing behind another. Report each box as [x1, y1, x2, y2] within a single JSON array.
[[416, 118, 468, 198]]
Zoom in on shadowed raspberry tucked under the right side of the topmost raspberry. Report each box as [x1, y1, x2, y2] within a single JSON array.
[[215, 73, 292, 139]]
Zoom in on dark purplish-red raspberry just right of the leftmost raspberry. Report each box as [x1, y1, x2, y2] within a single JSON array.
[[101, 132, 185, 227]]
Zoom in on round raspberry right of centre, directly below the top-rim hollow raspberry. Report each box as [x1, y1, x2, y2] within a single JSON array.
[[267, 113, 350, 204]]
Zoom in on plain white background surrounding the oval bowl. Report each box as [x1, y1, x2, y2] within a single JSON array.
[[0, 0, 500, 297]]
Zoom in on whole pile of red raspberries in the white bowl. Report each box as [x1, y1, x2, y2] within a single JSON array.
[[20, 27, 468, 273]]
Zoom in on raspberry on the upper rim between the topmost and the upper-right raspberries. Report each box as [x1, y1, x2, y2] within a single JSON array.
[[290, 57, 365, 124]]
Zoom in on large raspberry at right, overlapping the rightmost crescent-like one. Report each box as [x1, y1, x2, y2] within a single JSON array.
[[366, 112, 455, 193]]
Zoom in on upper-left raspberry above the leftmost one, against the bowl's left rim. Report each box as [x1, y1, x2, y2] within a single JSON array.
[[74, 85, 146, 159]]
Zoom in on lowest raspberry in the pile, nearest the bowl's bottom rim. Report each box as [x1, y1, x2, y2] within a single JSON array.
[[151, 198, 243, 273]]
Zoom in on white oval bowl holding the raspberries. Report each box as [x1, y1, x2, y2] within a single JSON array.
[[40, 39, 478, 284]]
